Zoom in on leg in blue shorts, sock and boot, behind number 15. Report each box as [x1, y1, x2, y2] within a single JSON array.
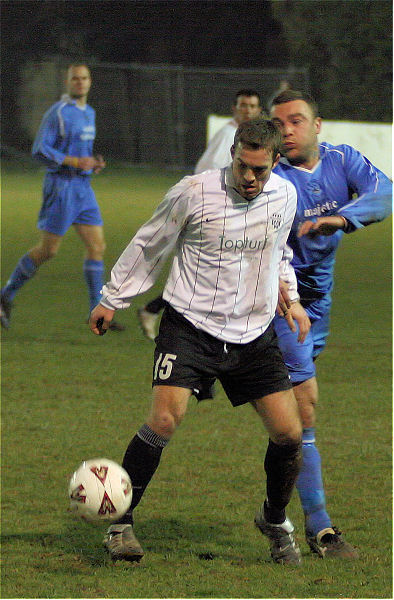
[[274, 312, 357, 558]]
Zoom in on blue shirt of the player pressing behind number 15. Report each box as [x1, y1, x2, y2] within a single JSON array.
[[274, 142, 392, 319]]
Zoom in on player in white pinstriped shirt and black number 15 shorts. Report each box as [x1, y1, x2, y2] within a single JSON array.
[[90, 119, 309, 564]]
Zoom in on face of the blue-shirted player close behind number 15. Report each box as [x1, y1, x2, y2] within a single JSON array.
[[271, 100, 321, 168]]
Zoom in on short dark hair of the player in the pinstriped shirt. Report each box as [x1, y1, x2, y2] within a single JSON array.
[[234, 118, 282, 160]]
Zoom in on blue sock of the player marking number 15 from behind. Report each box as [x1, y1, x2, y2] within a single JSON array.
[[296, 427, 332, 536]]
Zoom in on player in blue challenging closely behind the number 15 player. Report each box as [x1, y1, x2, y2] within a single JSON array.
[[271, 90, 392, 558]]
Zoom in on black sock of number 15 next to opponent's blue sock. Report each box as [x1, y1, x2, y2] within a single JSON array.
[[264, 440, 302, 524]]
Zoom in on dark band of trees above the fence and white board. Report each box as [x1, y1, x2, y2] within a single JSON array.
[[0, 0, 392, 146]]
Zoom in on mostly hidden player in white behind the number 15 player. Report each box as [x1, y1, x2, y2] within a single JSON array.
[[138, 89, 262, 340]]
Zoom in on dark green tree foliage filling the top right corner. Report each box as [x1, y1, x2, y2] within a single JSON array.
[[271, 0, 392, 123]]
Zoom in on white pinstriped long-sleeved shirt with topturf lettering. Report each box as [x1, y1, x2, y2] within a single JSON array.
[[101, 166, 297, 344]]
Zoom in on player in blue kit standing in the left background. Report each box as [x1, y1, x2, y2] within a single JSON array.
[[0, 64, 124, 331]]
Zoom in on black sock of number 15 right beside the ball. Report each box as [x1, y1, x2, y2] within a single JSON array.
[[119, 425, 168, 524]]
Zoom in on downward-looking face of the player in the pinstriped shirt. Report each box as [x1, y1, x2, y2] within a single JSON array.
[[232, 143, 279, 200]]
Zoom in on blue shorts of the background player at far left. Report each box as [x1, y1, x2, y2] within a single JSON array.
[[37, 173, 103, 235]]
